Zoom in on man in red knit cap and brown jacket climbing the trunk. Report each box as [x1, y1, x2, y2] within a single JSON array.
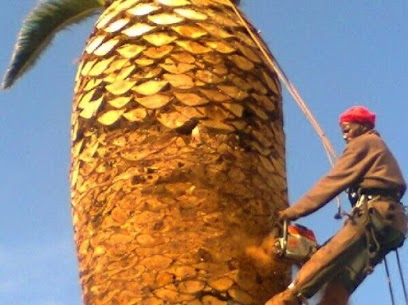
[[266, 106, 407, 305]]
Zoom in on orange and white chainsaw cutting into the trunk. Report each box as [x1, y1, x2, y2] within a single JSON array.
[[274, 220, 319, 264]]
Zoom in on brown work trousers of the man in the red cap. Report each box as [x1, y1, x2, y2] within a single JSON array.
[[291, 200, 407, 298]]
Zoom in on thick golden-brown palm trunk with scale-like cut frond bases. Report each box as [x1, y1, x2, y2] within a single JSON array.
[[71, 0, 288, 305]]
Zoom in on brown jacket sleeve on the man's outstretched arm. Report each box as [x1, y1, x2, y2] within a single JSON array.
[[285, 138, 368, 219]]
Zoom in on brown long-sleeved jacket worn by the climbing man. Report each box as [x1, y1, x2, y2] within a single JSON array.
[[285, 130, 406, 218]]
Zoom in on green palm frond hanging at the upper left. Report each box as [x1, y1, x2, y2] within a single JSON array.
[[2, 0, 106, 89]]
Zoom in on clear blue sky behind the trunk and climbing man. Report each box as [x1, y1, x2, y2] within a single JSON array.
[[0, 0, 408, 305]]
